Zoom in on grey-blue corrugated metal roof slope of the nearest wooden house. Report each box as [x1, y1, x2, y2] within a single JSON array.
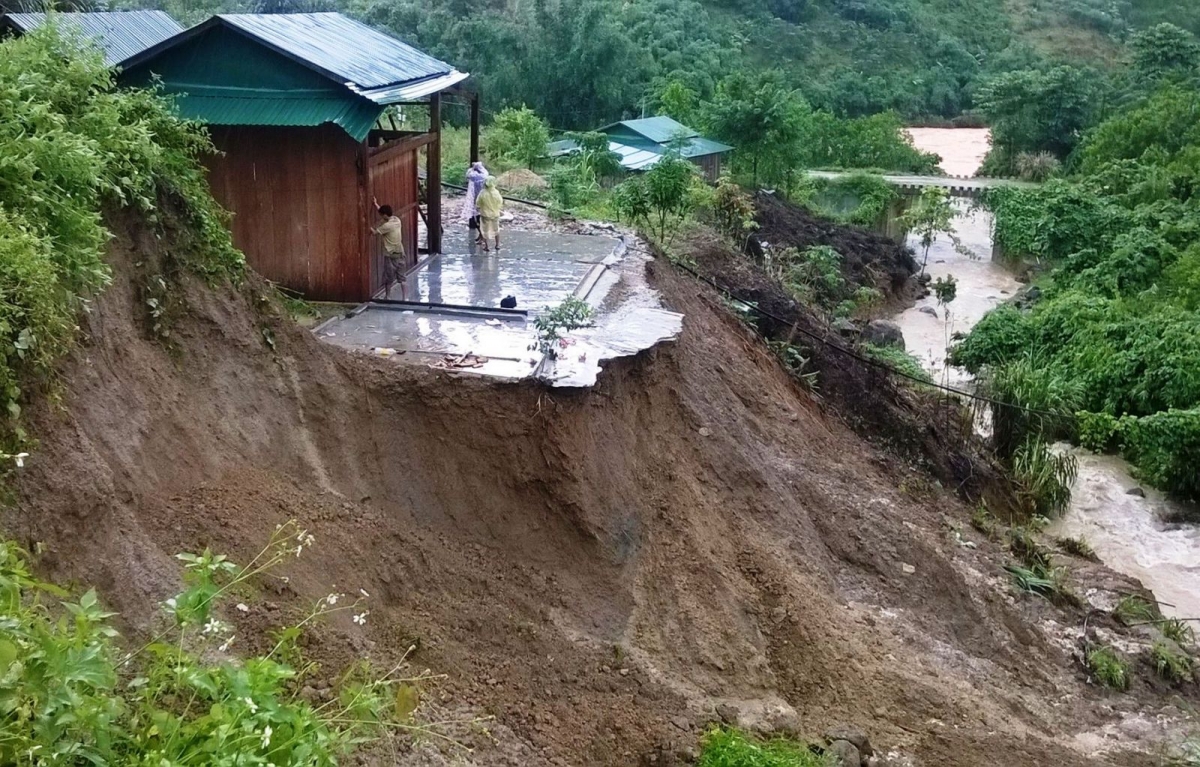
[[220, 13, 466, 103]]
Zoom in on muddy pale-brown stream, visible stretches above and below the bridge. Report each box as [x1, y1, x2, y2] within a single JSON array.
[[893, 128, 1200, 618]]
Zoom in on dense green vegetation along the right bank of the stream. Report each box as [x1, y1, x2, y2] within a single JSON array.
[[952, 28, 1200, 499]]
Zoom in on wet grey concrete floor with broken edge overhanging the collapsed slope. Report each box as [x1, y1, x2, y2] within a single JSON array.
[[317, 225, 683, 387]]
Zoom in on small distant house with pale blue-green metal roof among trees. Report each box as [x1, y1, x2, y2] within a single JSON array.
[[551, 116, 733, 181]]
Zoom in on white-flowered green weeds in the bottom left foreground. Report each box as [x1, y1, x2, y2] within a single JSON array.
[[0, 522, 425, 767]]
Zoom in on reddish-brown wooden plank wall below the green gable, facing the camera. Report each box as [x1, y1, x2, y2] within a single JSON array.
[[209, 125, 364, 301]]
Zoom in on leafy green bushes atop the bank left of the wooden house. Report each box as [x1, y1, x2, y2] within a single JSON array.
[[0, 26, 242, 453]]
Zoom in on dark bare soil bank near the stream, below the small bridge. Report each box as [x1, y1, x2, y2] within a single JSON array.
[[750, 192, 917, 300]]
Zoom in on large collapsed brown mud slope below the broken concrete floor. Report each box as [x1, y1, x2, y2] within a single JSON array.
[[7, 213, 1152, 767]]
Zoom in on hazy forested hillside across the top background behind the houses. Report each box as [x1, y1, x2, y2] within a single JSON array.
[[103, 0, 1200, 128]]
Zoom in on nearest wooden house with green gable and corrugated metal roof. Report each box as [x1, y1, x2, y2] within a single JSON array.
[[121, 13, 479, 301]]
